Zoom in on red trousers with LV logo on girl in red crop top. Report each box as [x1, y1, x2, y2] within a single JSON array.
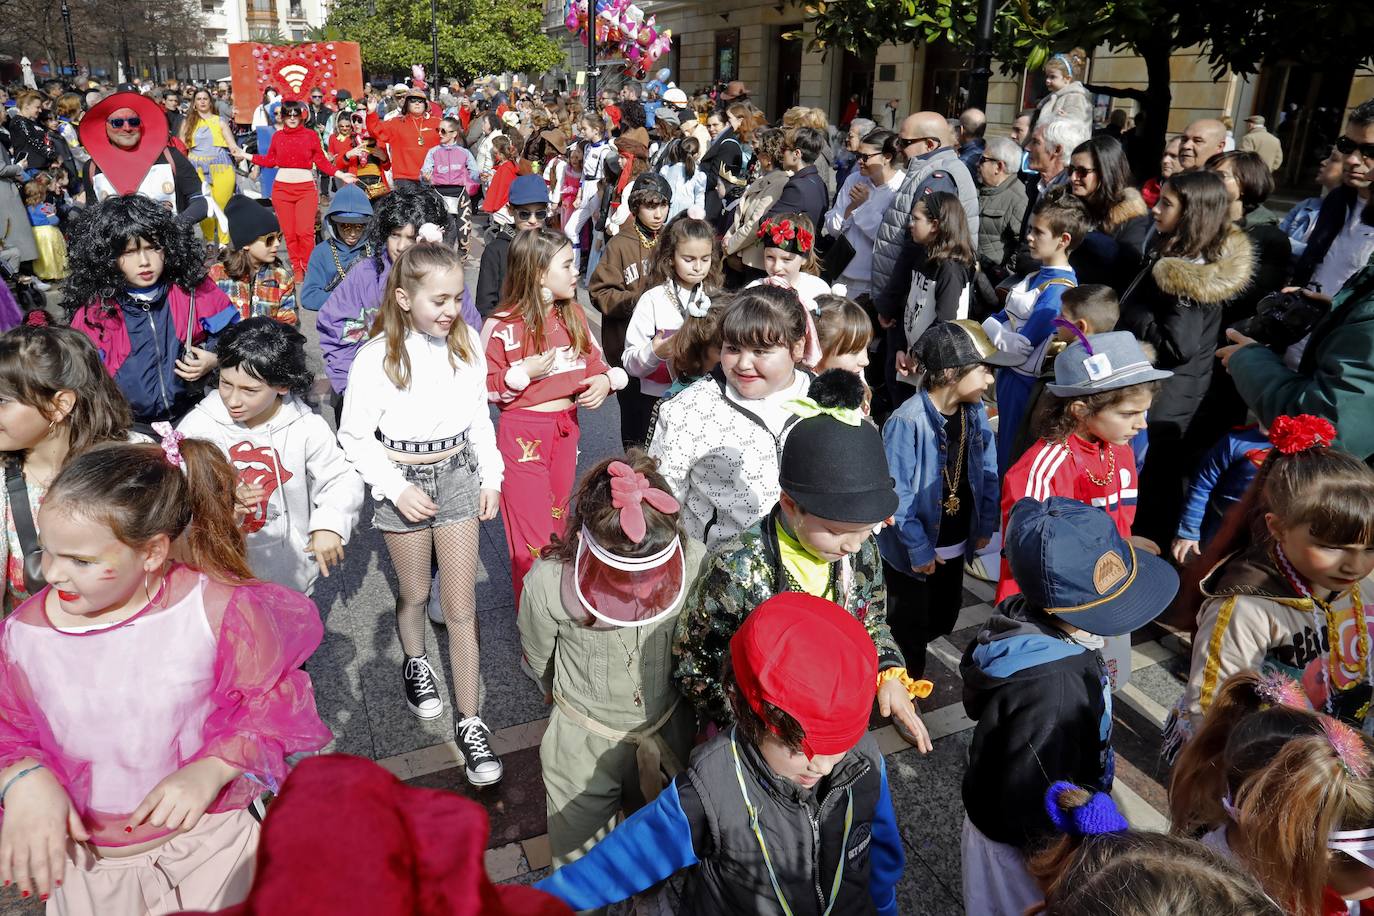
[[496, 407, 581, 612]]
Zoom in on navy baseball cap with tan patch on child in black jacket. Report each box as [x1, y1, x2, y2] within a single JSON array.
[[1003, 496, 1179, 636]]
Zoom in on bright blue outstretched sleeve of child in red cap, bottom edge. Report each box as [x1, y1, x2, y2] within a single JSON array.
[[534, 776, 697, 912]]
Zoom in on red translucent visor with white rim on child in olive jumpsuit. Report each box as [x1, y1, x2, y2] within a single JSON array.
[[573, 527, 687, 626]]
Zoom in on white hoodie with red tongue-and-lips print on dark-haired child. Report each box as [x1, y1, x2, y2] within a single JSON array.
[[177, 391, 363, 595]]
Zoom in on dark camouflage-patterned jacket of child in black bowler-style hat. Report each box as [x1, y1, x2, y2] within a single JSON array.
[[673, 508, 905, 725]]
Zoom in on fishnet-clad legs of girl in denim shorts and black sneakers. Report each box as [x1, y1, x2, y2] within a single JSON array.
[[382, 519, 481, 718]]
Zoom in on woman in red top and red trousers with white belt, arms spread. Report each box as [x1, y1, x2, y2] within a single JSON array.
[[236, 102, 357, 277]]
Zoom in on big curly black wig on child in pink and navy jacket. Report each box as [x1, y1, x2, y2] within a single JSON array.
[[62, 194, 207, 317]]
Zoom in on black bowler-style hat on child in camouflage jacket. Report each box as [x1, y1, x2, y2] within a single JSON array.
[[778, 369, 897, 525]]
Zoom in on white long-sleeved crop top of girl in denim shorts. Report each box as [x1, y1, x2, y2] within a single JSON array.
[[339, 328, 506, 503]]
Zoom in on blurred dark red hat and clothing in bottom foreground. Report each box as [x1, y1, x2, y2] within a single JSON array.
[[183, 754, 572, 916]]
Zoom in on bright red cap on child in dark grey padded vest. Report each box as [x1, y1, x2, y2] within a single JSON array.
[[730, 592, 878, 757]]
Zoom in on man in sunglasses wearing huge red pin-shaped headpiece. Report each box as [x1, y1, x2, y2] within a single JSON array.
[[77, 92, 210, 225]]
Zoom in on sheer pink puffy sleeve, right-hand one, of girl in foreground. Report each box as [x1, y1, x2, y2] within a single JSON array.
[[194, 582, 333, 810]]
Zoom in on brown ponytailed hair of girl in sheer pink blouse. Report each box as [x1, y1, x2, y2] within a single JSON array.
[[45, 434, 253, 584]]
